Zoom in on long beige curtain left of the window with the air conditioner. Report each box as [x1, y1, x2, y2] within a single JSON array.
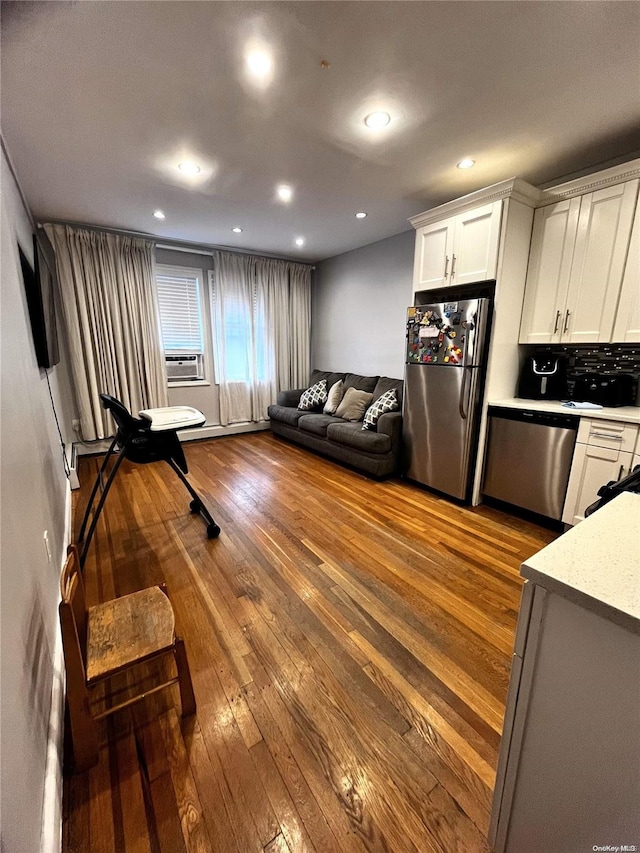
[[45, 225, 169, 440]]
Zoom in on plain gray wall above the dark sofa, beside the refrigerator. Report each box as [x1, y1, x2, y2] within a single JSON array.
[[311, 229, 415, 378]]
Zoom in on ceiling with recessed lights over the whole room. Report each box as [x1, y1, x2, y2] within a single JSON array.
[[1, 0, 640, 261]]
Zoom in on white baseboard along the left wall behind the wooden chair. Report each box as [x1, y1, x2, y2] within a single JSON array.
[[40, 483, 72, 853]]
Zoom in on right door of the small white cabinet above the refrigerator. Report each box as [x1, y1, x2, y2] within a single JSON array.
[[450, 201, 502, 284]]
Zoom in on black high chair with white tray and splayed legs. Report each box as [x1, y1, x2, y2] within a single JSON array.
[[78, 394, 220, 568]]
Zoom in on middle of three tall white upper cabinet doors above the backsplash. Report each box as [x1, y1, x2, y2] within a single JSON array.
[[562, 180, 638, 344]]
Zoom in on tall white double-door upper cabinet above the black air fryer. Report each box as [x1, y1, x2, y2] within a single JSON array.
[[520, 179, 639, 344]]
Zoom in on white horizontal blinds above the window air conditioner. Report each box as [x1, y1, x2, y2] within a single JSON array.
[[156, 273, 204, 353]]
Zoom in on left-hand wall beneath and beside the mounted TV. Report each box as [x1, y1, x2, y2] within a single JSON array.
[[0, 148, 72, 853]]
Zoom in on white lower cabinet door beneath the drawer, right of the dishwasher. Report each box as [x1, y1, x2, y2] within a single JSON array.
[[562, 444, 633, 524]]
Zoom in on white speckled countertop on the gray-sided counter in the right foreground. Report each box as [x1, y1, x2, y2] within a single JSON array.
[[520, 492, 640, 633]]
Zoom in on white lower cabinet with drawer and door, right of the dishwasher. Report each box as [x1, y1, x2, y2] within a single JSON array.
[[562, 418, 639, 525]]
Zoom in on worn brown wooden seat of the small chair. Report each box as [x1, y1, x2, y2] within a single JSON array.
[[87, 586, 175, 682]]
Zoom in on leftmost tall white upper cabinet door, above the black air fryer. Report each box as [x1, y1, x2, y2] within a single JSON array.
[[520, 198, 580, 344]]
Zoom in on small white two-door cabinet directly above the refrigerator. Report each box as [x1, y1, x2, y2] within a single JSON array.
[[414, 201, 502, 292]]
